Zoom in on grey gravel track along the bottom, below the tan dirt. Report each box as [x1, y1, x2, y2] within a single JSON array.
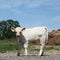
[[0, 55, 60, 60]]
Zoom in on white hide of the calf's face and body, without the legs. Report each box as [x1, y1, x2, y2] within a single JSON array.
[[15, 27, 48, 42]]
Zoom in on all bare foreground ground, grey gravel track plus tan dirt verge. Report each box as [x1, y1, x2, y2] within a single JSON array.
[[0, 51, 60, 60]]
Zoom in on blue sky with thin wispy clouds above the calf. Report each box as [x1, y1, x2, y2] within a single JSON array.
[[0, 0, 60, 31]]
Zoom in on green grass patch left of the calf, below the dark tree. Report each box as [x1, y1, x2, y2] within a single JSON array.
[[0, 39, 18, 53]]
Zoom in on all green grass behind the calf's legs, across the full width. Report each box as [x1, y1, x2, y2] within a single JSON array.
[[0, 39, 60, 53]]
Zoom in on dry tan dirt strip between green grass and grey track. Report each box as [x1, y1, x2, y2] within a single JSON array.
[[0, 50, 60, 57]]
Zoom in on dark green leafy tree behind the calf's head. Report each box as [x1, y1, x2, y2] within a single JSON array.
[[0, 19, 20, 39]]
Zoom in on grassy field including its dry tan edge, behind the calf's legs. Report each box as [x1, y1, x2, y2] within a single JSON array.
[[0, 39, 60, 54]]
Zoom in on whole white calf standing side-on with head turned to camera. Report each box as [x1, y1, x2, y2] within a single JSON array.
[[11, 27, 48, 56]]
